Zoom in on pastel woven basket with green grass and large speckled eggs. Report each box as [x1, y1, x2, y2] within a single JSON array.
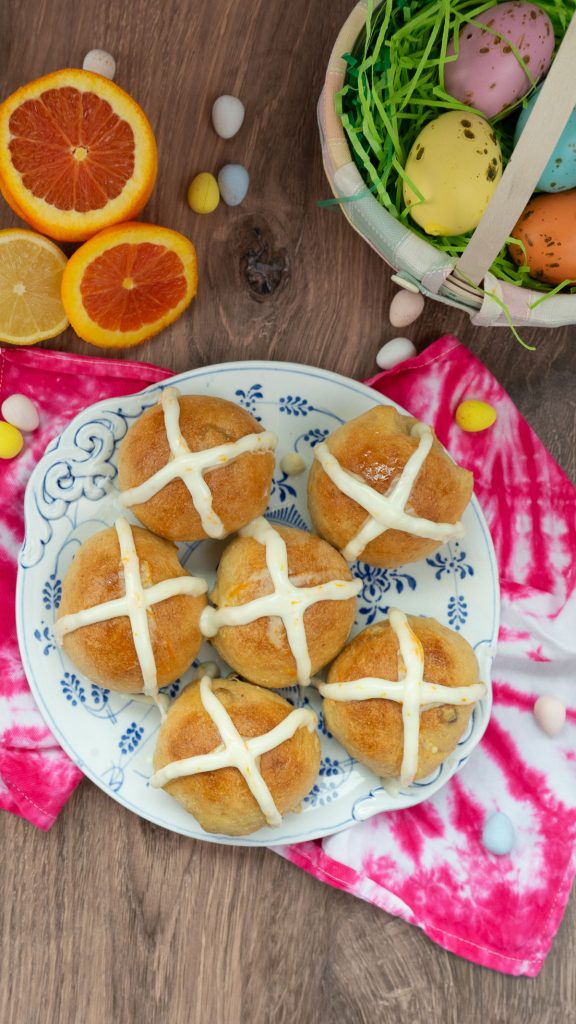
[[319, 0, 576, 327]]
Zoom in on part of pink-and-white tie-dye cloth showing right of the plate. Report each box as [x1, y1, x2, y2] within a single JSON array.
[[277, 337, 576, 976]]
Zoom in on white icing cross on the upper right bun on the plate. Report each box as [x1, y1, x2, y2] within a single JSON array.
[[314, 423, 464, 562]]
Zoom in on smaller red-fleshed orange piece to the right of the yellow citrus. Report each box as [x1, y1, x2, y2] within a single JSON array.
[[61, 223, 198, 348]]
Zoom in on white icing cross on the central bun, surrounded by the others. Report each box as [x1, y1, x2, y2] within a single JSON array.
[[200, 516, 362, 686]]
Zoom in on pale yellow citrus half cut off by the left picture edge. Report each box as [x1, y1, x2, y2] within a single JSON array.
[[0, 227, 68, 345]]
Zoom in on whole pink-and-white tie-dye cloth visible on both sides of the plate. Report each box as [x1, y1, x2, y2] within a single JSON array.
[[0, 337, 576, 975]]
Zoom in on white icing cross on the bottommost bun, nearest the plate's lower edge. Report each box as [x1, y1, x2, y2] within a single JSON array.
[[150, 676, 318, 825]]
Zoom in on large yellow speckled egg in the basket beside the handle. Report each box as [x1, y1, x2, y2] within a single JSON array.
[[404, 111, 502, 236]]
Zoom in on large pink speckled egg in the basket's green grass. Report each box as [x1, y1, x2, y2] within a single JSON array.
[[444, 0, 554, 118]]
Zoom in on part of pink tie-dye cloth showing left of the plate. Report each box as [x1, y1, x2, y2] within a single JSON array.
[[0, 348, 170, 828]]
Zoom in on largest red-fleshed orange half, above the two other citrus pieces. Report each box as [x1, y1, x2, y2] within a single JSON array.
[[0, 69, 158, 242]]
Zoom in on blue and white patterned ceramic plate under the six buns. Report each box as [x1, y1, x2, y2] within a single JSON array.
[[16, 362, 499, 846]]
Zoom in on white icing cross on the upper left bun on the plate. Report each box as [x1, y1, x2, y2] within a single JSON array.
[[120, 387, 278, 538]]
